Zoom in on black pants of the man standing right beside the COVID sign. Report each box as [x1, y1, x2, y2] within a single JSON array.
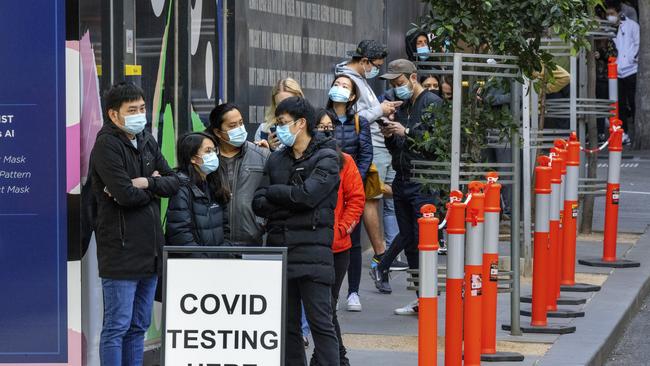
[[285, 277, 339, 366]]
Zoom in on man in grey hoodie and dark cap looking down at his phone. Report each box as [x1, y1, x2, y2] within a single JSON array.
[[335, 40, 401, 311]]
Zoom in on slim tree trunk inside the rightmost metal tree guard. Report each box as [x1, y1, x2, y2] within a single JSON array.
[[580, 47, 596, 234]]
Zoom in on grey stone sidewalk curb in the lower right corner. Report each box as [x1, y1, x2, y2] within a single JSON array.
[[538, 228, 650, 366]]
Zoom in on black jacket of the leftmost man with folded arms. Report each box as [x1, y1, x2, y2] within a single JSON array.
[[90, 122, 179, 279]]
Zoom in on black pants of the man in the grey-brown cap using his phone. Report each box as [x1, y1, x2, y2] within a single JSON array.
[[378, 176, 438, 271]]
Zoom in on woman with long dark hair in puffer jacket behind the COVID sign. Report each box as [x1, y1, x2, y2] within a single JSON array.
[[165, 132, 229, 256]]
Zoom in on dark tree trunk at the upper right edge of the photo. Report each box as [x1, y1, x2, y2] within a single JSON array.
[[633, 0, 650, 150]]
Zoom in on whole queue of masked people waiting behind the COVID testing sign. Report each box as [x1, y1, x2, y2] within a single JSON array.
[[90, 40, 444, 365]]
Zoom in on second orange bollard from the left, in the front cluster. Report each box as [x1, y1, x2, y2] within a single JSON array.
[[445, 191, 466, 366]]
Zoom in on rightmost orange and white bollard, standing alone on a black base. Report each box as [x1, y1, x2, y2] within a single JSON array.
[[578, 119, 641, 268]]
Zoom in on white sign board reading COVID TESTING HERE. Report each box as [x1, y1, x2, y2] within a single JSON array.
[[164, 258, 283, 366]]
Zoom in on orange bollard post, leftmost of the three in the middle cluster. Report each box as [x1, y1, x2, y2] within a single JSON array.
[[530, 156, 551, 327]]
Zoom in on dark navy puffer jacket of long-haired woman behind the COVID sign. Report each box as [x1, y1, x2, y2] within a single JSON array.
[[165, 172, 225, 257]]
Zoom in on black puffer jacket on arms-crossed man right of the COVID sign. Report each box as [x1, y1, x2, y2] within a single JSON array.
[[253, 135, 340, 284]]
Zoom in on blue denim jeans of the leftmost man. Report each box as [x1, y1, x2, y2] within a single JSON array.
[[99, 276, 158, 366]]
